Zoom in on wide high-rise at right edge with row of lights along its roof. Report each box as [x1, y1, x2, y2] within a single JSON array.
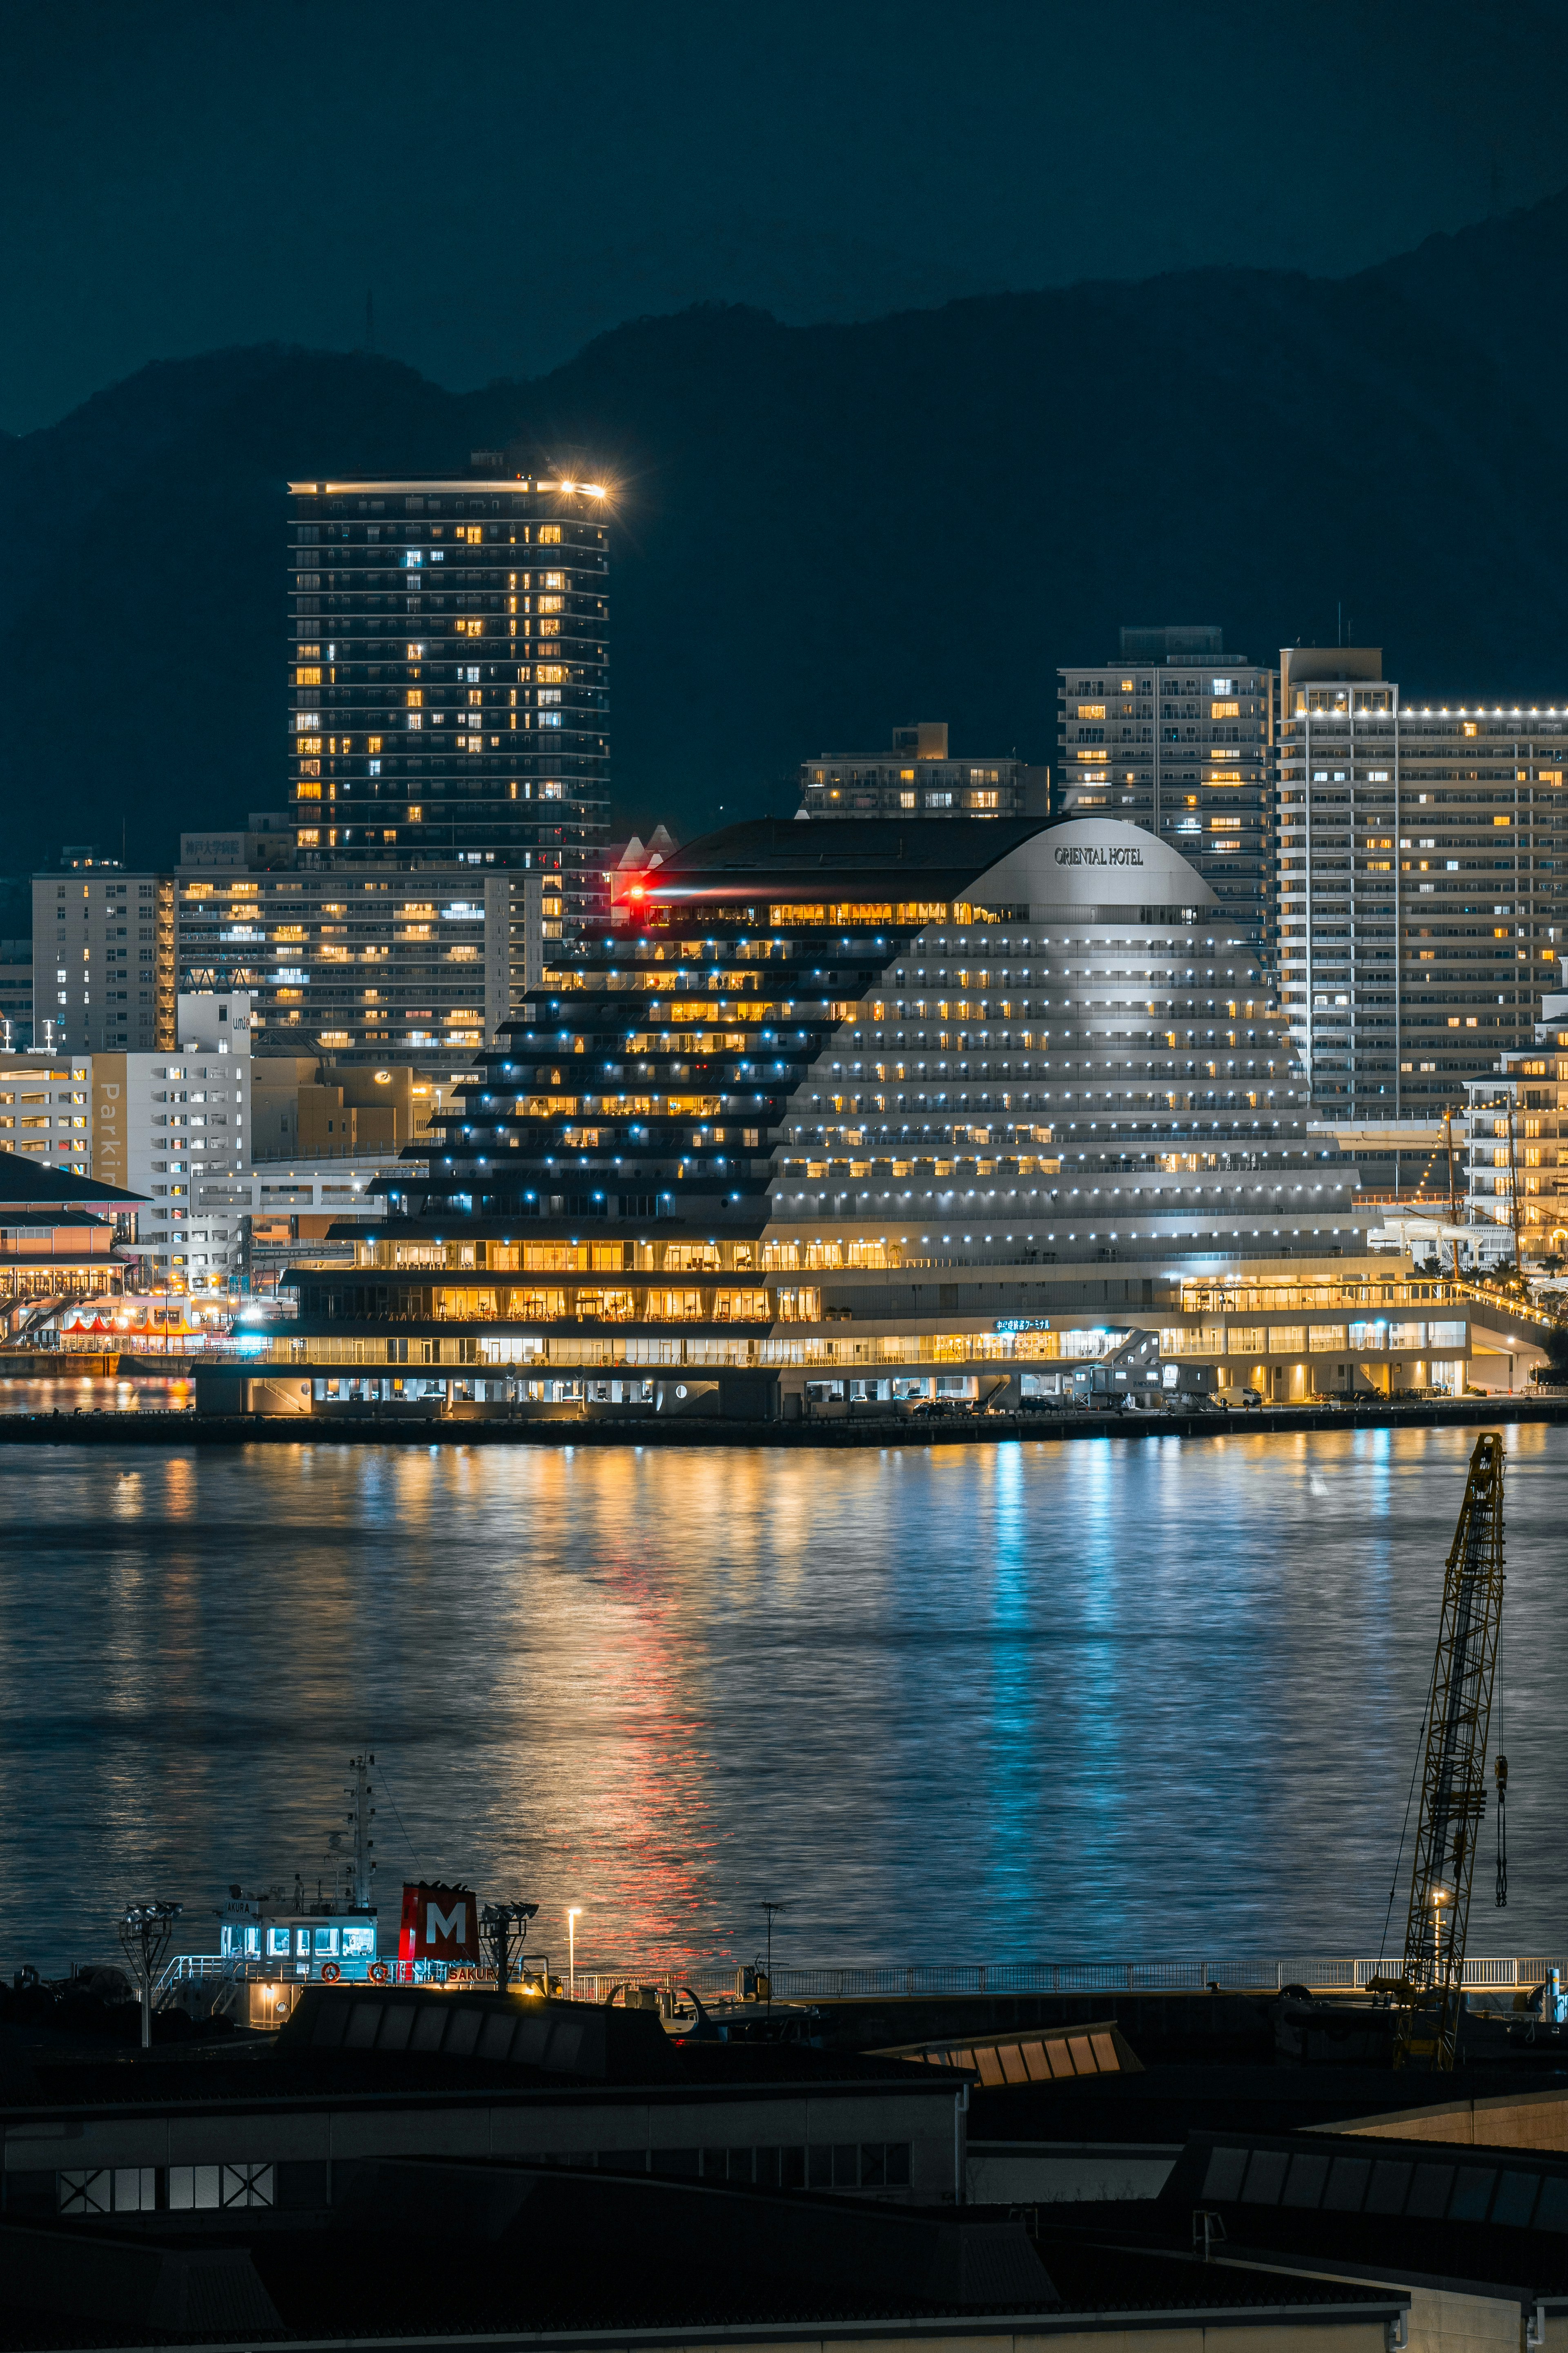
[[1279, 647, 1568, 1186]]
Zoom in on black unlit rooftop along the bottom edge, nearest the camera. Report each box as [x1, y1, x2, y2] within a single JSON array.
[[0, 2160, 1403, 2353]]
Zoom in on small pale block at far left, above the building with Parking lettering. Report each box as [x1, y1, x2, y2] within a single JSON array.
[[33, 852, 176, 1054]]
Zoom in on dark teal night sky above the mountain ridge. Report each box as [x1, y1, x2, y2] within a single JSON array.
[[0, 0, 1568, 433]]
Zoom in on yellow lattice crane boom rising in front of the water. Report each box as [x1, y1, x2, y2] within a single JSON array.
[[1389, 1431, 1507, 2068]]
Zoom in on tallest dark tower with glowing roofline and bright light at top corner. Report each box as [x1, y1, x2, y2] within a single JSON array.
[[287, 464, 609, 932]]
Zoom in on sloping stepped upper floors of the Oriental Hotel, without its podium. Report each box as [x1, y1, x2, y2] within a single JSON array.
[[352, 819, 1354, 1271]]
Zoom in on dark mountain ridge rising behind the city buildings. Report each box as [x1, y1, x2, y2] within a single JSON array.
[[0, 198, 1568, 873]]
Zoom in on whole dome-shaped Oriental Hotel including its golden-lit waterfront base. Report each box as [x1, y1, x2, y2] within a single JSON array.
[[214, 819, 1561, 1416]]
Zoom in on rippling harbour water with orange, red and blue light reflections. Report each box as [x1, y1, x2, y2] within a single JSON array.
[[0, 1428, 1568, 1969]]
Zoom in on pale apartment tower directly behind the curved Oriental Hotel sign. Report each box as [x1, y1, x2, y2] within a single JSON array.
[[1058, 628, 1276, 946]]
